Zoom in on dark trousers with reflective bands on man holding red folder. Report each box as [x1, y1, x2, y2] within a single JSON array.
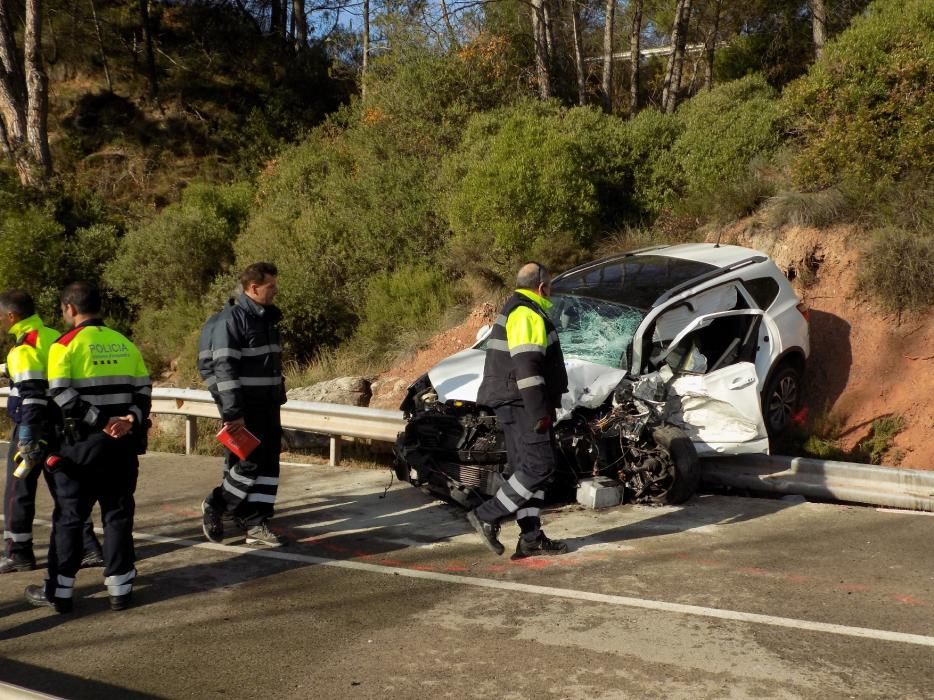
[[208, 404, 282, 529]]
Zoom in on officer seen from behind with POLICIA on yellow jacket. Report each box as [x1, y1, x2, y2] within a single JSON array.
[[25, 282, 152, 612]]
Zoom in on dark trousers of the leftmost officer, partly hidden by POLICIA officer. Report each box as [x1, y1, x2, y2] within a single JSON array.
[[3, 425, 101, 559]]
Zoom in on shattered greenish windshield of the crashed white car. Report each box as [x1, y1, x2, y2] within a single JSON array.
[[549, 294, 646, 369]]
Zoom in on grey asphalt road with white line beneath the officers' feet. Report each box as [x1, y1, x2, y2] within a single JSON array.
[[0, 455, 934, 700]]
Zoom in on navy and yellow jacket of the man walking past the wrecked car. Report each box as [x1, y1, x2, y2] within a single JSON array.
[[477, 289, 568, 420]]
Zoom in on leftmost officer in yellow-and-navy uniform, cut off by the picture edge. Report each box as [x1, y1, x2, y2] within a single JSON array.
[[0, 289, 104, 574]]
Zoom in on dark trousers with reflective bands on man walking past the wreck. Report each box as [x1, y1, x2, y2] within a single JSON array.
[[474, 404, 555, 540]]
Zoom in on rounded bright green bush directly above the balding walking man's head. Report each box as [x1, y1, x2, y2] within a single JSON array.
[[445, 102, 626, 275]]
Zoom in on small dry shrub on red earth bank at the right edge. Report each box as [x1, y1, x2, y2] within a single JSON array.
[[859, 227, 934, 312]]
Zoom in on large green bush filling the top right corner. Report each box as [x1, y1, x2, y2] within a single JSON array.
[[782, 0, 934, 187]]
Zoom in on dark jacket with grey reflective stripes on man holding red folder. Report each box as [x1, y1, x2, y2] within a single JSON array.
[[198, 294, 285, 421]]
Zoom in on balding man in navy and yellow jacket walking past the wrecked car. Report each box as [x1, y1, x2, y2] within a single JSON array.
[[467, 262, 568, 559]]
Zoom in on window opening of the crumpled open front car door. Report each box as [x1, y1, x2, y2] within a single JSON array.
[[654, 312, 762, 374]]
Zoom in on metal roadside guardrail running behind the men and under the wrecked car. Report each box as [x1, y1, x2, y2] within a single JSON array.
[[0, 388, 934, 512]]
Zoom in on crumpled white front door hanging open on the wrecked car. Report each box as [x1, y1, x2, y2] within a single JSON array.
[[654, 309, 769, 456]]
